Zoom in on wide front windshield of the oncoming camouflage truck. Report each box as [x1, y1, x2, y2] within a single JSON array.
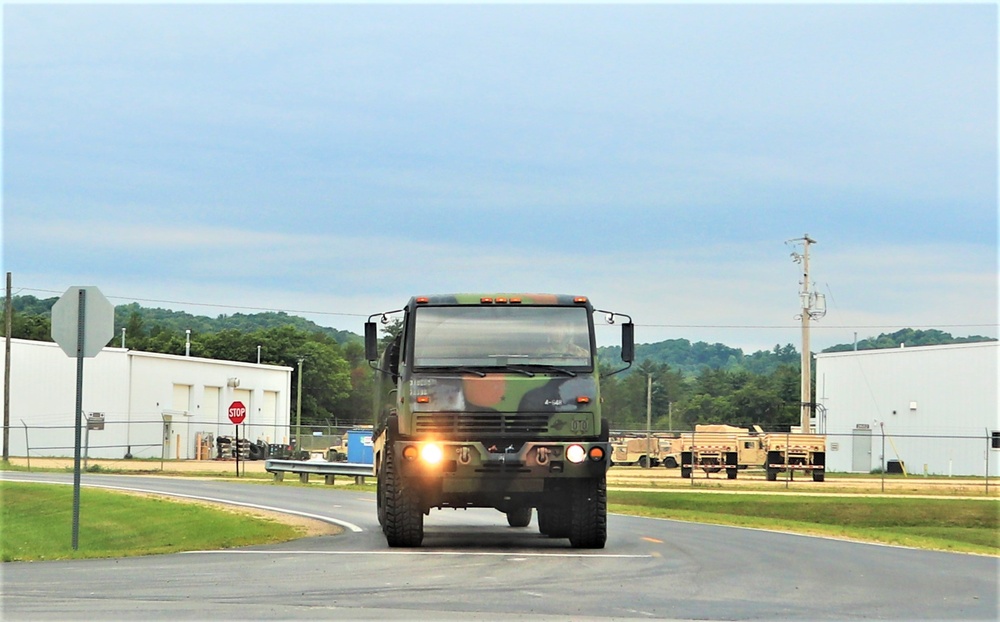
[[413, 306, 593, 369]]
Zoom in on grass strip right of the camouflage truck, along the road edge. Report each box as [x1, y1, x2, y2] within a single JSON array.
[[608, 490, 1000, 555]]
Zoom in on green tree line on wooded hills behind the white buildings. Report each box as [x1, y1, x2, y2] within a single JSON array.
[[5, 296, 990, 431]]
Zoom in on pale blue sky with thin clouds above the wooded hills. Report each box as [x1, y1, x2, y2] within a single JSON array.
[[2, 2, 998, 351]]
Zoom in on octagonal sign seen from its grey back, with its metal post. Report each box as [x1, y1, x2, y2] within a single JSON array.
[[52, 286, 115, 551]]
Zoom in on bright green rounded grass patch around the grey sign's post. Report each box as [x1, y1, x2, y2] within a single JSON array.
[[0, 482, 305, 562]]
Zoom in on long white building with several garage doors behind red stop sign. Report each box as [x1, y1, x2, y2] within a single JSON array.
[[0, 339, 292, 459]]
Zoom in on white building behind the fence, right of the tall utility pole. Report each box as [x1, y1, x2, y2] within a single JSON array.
[[816, 341, 1000, 477]]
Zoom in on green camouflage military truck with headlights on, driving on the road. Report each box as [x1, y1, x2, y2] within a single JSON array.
[[365, 294, 634, 548]]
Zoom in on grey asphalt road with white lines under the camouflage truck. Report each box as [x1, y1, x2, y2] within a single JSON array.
[[0, 472, 1000, 620]]
